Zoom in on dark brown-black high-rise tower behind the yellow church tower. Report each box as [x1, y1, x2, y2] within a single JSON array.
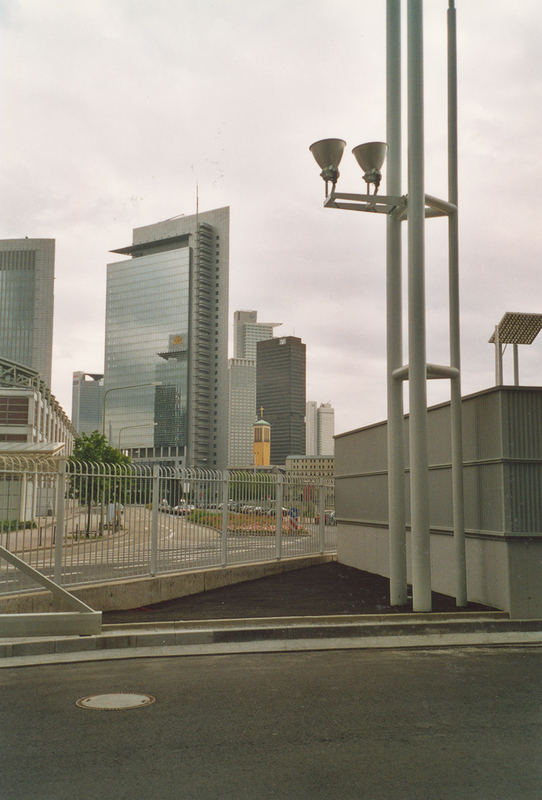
[[256, 336, 306, 464]]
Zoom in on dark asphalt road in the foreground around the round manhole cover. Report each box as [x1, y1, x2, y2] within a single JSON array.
[[0, 648, 542, 800]]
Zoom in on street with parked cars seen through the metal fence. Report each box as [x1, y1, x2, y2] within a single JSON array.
[[0, 506, 337, 593]]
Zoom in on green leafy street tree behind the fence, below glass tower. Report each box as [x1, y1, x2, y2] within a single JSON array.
[[68, 431, 131, 536]]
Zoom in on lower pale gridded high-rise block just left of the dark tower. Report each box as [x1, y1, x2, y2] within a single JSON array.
[[228, 358, 256, 467]]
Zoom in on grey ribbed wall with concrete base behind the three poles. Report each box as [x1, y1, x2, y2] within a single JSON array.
[[336, 386, 542, 618]]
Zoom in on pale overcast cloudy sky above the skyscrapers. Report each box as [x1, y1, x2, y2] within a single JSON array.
[[0, 0, 542, 432]]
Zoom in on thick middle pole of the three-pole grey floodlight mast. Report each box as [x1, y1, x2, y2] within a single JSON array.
[[407, 0, 431, 611]]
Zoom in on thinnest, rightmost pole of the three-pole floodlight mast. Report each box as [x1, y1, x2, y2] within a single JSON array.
[[447, 0, 467, 607]]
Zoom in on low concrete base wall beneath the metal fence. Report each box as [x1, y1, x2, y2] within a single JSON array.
[[0, 554, 336, 614]]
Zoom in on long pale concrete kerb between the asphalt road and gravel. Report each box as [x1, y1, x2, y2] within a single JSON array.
[[0, 612, 542, 667]]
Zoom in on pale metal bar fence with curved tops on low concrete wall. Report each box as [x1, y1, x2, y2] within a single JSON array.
[[0, 456, 336, 594]]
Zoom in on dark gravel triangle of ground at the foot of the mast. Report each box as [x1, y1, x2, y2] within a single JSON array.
[[103, 561, 498, 623]]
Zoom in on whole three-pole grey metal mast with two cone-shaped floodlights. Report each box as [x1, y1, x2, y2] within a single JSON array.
[[310, 0, 467, 611]]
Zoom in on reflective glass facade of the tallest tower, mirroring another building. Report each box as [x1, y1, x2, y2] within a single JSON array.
[[105, 246, 190, 448]]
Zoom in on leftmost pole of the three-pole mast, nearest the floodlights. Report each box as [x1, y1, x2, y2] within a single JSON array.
[[386, 0, 407, 606]]
